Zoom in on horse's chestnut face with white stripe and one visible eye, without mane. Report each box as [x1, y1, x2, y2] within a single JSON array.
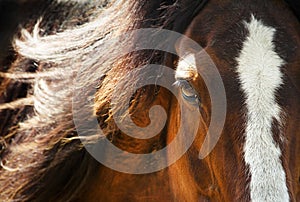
[[168, 1, 298, 201]]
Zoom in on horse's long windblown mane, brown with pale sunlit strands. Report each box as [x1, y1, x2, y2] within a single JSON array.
[[0, 0, 206, 201]]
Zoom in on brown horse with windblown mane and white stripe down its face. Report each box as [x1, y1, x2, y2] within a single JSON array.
[[0, 0, 300, 201]]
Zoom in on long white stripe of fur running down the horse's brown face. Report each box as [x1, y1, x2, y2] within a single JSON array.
[[236, 16, 289, 202]]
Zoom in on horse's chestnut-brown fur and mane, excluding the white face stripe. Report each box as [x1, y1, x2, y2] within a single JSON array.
[[0, 0, 300, 201]]
